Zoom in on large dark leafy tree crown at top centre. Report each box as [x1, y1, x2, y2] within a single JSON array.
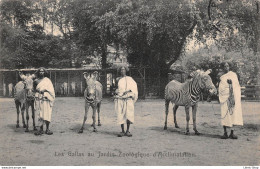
[[96, 0, 196, 68]]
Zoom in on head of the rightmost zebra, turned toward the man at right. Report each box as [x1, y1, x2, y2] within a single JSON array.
[[198, 69, 217, 95]]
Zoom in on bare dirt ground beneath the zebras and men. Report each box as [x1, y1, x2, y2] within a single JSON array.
[[0, 97, 260, 166]]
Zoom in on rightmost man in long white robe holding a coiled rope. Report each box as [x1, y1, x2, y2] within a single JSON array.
[[219, 62, 243, 139]]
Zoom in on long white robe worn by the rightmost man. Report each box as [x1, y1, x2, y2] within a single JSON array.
[[219, 71, 243, 127]]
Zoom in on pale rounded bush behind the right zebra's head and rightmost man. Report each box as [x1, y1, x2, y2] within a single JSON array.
[[182, 45, 259, 85]]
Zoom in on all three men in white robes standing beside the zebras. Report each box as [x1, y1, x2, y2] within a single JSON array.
[[18, 62, 243, 139]]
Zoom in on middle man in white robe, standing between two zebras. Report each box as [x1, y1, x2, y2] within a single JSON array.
[[115, 66, 138, 137]]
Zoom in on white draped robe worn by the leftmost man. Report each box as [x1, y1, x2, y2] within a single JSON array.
[[35, 77, 55, 122]]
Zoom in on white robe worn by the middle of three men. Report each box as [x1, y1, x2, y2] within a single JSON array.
[[115, 76, 138, 124]]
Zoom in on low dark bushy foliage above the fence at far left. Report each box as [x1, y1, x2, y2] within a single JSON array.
[[0, 21, 70, 68]]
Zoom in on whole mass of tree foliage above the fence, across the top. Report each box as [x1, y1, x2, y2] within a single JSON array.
[[0, 0, 260, 78]]
